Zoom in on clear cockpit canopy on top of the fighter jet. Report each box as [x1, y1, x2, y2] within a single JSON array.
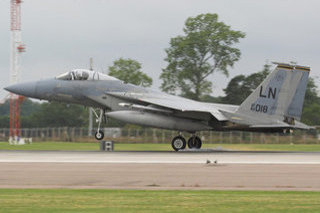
[[56, 69, 118, 81]]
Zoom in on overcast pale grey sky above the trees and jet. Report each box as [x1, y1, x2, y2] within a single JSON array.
[[0, 0, 320, 97]]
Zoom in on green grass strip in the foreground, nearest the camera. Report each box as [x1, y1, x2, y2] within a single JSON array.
[[0, 189, 320, 213]]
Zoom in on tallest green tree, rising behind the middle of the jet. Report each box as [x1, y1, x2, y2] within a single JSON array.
[[160, 13, 245, 100]]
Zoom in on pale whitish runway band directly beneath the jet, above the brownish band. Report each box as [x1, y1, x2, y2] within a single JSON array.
[[0, 151, 320, 164]]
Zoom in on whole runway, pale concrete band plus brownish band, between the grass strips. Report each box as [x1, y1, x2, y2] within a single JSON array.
[[0, 151, 320, 191]]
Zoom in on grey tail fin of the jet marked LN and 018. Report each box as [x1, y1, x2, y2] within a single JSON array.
[[237, 63, 310, 124]]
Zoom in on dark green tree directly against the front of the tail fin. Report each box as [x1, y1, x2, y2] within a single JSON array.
[[222, 64, 271, 104]]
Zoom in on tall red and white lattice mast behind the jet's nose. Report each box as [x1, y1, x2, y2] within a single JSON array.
[[9, 0, 25, 142]]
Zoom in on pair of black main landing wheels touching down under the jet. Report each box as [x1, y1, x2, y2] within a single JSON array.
[[171, 135, 202, 152]]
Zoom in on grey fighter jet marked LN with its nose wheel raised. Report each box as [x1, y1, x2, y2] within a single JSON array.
[[5, 63, 311, 151]]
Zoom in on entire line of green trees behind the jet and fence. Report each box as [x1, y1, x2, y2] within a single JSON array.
[[0, 13, 320, 128]]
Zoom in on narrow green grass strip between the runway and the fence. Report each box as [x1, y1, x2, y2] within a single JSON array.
[[0, 142, 320, 152]]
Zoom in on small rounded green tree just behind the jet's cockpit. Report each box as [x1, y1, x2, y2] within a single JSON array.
[[109, 58, 152, 87]]
